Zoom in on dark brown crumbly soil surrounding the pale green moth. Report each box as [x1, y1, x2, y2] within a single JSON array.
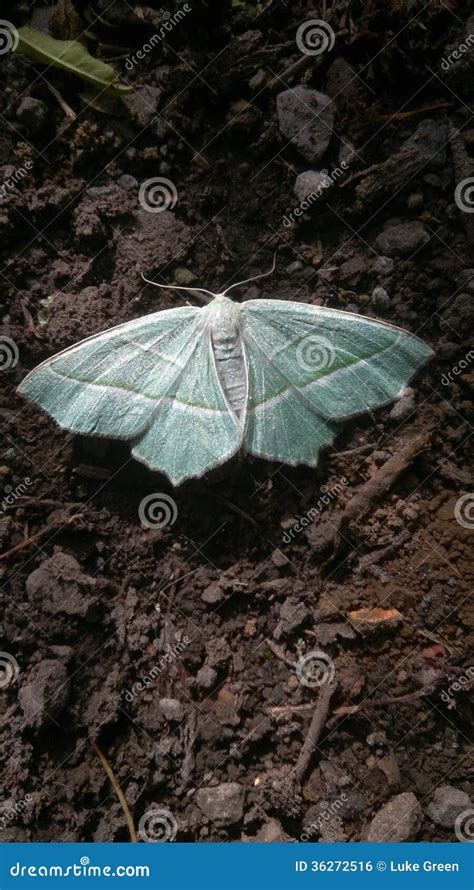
[[0, 0, 474, 842]]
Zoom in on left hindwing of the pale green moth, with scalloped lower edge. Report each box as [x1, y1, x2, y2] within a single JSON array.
[[132, 328, 242, 485]]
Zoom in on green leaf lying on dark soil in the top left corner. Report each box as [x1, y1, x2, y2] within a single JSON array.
[[15, 25, 132, 93]]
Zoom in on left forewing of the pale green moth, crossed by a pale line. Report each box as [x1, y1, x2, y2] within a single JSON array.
[[18, 307, 200, 440]]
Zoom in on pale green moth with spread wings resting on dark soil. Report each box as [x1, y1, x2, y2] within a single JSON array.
[[19, 266, 432, 485]]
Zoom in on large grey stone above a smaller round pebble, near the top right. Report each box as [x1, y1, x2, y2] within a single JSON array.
[[276, 85, 334, 163]]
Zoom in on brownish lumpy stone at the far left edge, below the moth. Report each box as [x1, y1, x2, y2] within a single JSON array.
[[18, 658, 69, 729]]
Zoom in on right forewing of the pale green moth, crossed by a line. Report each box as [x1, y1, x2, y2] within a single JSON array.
[[241, 300, 432, 420]]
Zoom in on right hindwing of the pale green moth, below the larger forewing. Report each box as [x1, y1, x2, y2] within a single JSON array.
[[244, 329, 336, 466]]
